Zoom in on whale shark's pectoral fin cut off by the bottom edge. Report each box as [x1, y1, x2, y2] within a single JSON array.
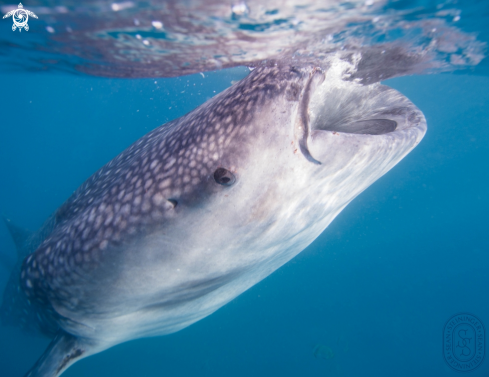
[[24, 330, 95, 377]]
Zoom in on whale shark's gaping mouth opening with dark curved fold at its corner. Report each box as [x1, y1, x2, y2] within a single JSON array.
[[295, 64, 419, 165]]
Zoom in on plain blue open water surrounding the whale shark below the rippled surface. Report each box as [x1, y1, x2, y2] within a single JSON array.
[[0, 68, 489, 377]]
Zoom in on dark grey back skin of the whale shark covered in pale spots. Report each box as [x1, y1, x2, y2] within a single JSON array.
[[21, 64, 303, 328]]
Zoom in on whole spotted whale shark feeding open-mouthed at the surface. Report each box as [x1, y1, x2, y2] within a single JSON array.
[[3, 65, 426, 377]]
